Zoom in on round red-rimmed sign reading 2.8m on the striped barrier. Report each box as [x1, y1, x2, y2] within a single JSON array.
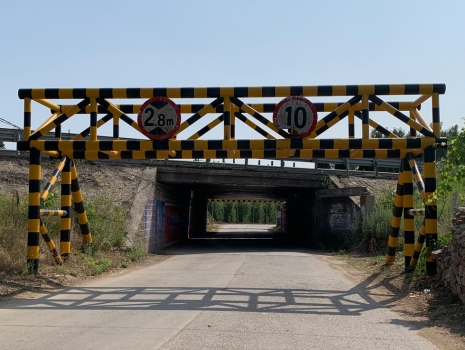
[[137, 97, 181, 140]]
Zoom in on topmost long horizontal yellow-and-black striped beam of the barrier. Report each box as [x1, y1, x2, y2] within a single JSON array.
[[18, 84, 446, 99]]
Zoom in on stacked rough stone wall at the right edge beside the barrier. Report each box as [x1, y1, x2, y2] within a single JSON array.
[[433, 207, 465, 303]]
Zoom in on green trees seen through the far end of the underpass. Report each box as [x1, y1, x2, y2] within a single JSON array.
[[207, 202, 277, 224]]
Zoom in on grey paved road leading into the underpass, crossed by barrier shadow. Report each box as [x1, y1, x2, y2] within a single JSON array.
[[0, 226, 436, 350]]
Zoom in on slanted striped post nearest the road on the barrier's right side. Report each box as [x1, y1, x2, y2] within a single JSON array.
[[385, 162, 404, 265]]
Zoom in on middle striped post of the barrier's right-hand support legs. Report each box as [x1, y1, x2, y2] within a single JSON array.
[[402, 158, 415, 272]]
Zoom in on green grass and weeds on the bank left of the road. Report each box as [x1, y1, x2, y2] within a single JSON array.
[[0, 187, 132, 275]]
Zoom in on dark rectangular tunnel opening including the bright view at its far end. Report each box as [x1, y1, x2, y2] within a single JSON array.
[[156, 165, 332, 250]]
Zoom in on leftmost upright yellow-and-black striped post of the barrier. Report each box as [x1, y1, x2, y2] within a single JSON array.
[[27, 148, 42, 275]]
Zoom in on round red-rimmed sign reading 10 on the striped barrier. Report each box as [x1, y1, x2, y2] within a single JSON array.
[[273, 96, 318, 138]]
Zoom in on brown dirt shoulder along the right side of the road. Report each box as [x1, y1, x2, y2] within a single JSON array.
[[318, 254, 465, 350]]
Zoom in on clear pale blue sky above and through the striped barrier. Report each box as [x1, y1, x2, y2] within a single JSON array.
[[0, 0, 465, 165]]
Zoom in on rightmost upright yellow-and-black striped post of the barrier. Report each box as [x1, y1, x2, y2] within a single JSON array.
[[424, 146, 438, 276]]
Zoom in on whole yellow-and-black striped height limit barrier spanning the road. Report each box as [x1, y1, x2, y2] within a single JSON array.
[[17, 84, 447, 274]]
